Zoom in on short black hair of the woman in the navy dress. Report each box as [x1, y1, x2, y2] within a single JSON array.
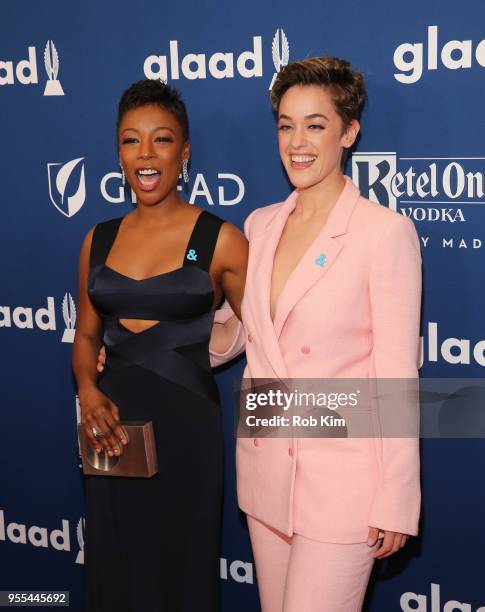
[[116, 79, 189, 141]]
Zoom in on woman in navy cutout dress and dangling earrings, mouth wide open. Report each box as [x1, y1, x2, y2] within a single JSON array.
[[73, 80, 247, 612]]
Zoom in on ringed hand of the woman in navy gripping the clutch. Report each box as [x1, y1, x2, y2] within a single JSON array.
[[79, 387, 129, 456]]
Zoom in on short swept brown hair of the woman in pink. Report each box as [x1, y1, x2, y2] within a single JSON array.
[[271, 55, 366, 127]]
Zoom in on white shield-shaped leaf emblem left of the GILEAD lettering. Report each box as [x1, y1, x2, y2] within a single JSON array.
[[47, 157, 86, 218]]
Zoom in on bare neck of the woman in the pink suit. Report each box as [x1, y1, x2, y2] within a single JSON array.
[[294, 170, 345, 220]]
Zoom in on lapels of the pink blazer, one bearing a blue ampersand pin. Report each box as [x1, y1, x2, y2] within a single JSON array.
[[268, 177, 360, 339]]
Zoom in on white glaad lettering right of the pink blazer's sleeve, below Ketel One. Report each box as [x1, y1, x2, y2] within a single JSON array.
[[419, 321, 485, 368]]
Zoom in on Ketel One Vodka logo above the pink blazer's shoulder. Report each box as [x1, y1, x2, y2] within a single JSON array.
[[352, 152, 485, 223]]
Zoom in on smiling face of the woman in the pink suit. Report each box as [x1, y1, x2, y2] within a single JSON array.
[[278, 85, 359, 190]]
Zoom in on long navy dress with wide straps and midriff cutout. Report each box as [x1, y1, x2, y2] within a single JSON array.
[[85, 211, 223, 612]]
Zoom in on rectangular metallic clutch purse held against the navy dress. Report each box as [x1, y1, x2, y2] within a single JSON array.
[[77, 421, 158, 478]]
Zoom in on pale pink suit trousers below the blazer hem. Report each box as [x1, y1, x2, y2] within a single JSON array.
[[248, 516, 377, 612]]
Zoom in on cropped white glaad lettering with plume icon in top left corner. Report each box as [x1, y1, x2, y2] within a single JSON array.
[[0, 40, 64, 96]]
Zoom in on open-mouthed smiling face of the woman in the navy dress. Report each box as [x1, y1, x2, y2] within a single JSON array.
[[118, 104, 190, 205]]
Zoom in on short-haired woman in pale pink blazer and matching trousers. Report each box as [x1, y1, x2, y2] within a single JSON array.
[[212, 57, 421, 612]]
